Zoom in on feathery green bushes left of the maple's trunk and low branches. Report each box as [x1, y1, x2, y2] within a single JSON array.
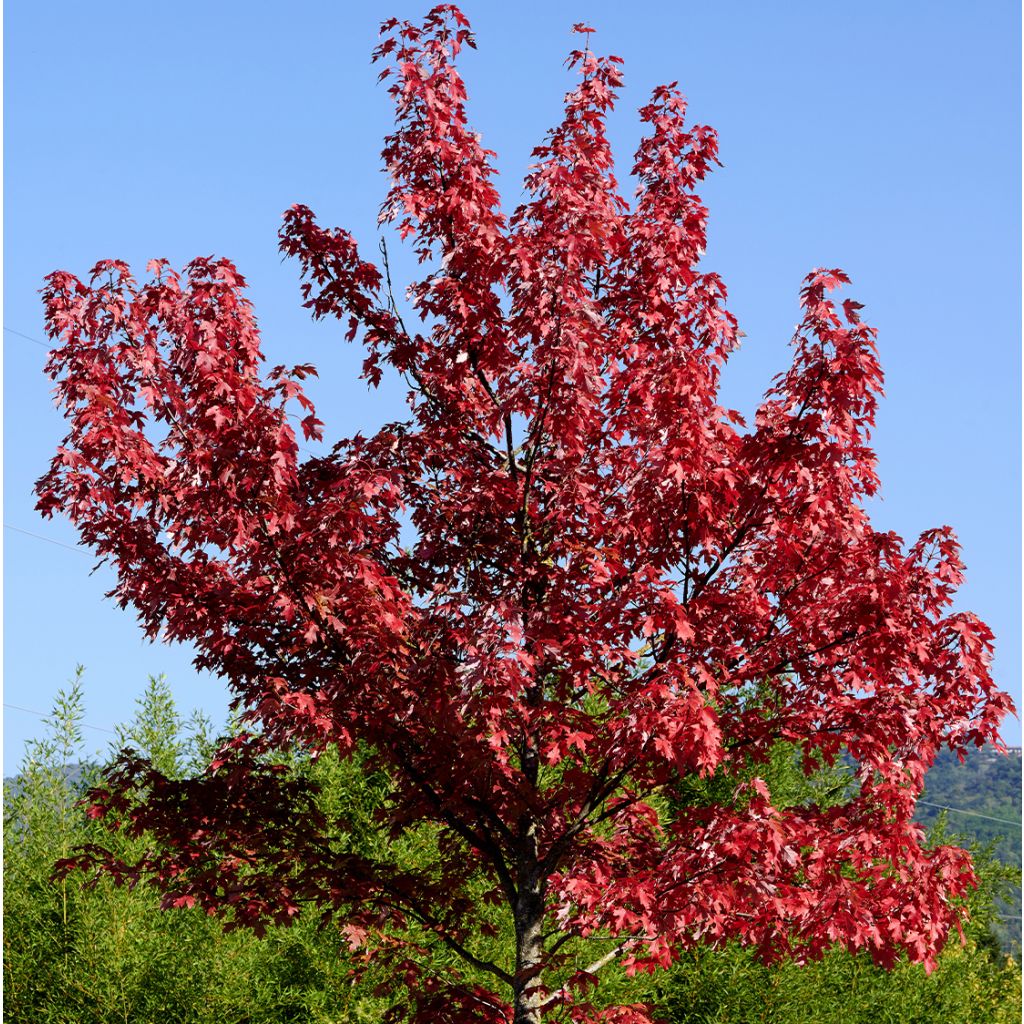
[[4, 673, 379, 1024]]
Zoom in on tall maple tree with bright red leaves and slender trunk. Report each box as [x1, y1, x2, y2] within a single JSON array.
[[38, 6, 1011, 1024]]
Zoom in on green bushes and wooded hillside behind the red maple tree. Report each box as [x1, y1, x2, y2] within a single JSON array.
[[4, 676, 1021, 1024]]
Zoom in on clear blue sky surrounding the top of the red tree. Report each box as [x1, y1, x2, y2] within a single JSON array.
[[3, 0, 1021, 773]]
